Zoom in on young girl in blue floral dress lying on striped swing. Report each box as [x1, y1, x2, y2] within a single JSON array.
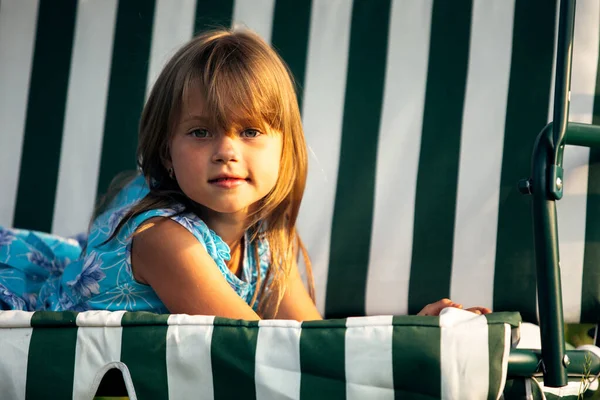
[[0, 31, 481, 321]]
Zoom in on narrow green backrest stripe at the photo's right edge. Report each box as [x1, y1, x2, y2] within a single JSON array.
[[581, 38, 600, 323]]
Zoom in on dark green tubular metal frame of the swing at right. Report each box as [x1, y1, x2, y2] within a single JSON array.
[[508, 0, 600, 387]]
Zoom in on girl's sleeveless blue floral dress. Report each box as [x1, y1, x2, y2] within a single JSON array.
[[0, 175, 270, 313]]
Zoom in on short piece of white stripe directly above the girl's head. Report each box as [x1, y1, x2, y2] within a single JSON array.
[[233, 0, 275, 44]]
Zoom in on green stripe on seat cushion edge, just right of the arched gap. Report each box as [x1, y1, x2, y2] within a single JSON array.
[[121, 313, 169, 399]]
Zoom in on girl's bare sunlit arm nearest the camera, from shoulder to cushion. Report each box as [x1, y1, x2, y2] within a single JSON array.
[[131, 217, 260, 320]]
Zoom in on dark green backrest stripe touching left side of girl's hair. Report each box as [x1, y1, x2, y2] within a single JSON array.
[[98, 0, 155, 195]]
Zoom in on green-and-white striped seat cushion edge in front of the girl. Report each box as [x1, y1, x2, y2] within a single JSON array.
[[0, 309, 520, 399]]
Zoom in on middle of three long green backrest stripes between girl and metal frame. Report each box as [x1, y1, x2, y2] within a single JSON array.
[[408, 0, 472, 314]]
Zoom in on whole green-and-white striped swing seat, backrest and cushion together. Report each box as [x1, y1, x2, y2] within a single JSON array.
[[0, 0, 600, 399]]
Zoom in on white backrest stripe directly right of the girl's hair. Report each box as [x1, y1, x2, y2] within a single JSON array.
[[298, 0, 352, 314]]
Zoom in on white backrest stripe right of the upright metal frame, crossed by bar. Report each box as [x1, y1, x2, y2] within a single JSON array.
[[556, 1, 600, 323]]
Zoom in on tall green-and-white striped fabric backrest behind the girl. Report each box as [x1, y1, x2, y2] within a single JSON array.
[[0, 0, 600, 322]]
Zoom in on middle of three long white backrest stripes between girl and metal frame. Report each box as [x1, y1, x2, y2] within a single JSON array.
[[366, 0, 433, 315]]
